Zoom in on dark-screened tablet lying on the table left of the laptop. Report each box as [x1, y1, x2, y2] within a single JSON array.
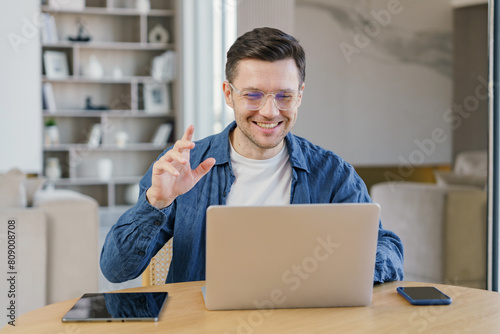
[[62, 292, 168, 322]]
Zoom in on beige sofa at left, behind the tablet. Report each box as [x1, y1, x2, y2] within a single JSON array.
[[0, 171, 98, 320]]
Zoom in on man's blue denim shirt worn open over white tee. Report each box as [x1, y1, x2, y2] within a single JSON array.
[[101, 122, 403, 283]]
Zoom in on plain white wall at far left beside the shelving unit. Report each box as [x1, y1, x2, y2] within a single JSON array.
[[0, 0, 42, 173]]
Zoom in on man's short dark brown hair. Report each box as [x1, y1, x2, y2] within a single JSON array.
[[226, 27, 306, 85]]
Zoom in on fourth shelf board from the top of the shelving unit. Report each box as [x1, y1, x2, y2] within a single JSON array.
[[43, 109, 175, 121]]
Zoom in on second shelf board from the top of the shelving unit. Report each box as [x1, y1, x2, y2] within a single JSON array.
[[42, 41, 175, 51]]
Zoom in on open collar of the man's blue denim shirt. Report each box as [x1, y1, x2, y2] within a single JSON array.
[[212, 121, 309, 172]]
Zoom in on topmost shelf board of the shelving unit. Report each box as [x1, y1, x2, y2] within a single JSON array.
[[41, 6, 175, 17]]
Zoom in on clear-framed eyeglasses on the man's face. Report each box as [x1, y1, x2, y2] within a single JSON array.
[[229, 83, 300, 110]]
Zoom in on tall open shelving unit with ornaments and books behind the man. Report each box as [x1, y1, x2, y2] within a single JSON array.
[[41, 0, 179, 208]]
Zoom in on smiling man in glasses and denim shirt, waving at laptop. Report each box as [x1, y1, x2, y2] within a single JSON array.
[[101, 28, 403, 283]]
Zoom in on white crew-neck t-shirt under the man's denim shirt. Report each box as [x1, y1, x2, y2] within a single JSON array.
[[226, 144, 292, 206]]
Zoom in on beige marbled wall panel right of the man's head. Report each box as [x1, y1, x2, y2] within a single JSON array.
[[294, 0, 452, 167]]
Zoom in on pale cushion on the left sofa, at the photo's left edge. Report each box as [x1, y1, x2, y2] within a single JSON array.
[[0, 169, 27, 208]]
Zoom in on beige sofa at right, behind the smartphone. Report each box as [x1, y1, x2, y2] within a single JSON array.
[[370, 152, 487, 288]]
